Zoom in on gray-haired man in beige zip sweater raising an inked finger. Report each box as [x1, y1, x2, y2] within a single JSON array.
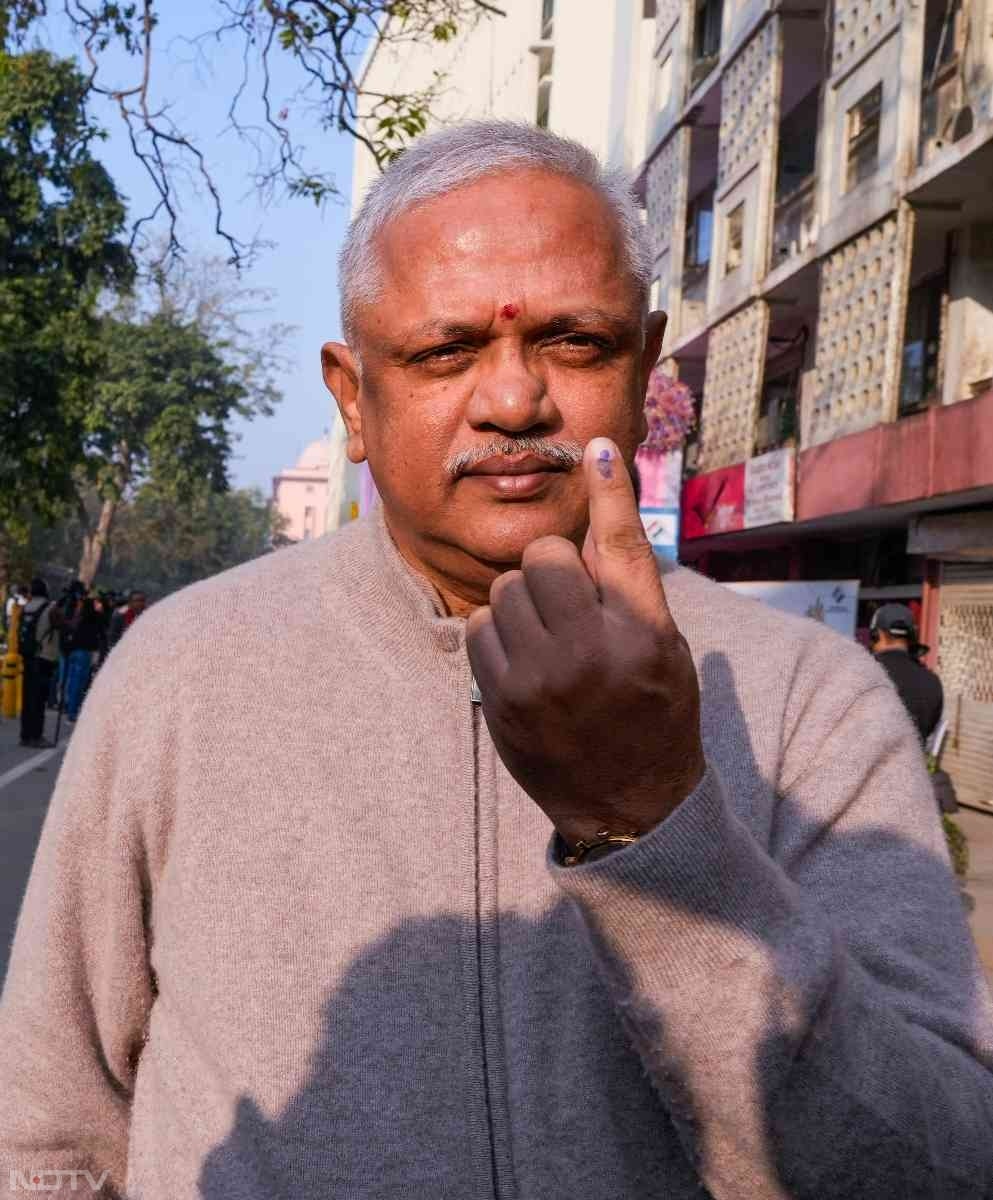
[[0, 124, 993, 1200]]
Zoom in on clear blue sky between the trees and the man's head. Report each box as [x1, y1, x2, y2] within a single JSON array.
[[43, 0, 366, 494]]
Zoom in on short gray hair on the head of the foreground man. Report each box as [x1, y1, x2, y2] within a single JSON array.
[[338, 121, 651, 346]]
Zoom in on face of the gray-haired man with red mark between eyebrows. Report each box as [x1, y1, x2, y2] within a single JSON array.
[[324, 169, 662, 597]]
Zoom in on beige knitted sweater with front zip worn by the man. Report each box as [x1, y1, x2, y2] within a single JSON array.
[[0, 508, 993, 1200]]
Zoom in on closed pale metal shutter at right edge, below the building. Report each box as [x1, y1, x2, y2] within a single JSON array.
[[938, 563, 993, 812]]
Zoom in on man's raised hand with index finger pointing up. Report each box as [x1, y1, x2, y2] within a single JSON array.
[[468, 438, 704, 845]]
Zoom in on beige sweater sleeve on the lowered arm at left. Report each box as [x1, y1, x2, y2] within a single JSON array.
[[0, 628, 161, 1198]]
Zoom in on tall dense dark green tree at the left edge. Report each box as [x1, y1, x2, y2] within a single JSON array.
[[0, 50, 133, 542]]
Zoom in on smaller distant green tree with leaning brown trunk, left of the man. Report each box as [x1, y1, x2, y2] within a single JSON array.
[[74, 294, 278, 584]]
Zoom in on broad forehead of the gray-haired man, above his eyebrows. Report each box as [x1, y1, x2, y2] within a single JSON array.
[[364, 169, 638, 324]]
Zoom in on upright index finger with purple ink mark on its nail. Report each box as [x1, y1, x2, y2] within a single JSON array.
[[583, 438, 666, 613]]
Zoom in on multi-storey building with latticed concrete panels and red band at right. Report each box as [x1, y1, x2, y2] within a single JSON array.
[[639, 0, 993, 808]]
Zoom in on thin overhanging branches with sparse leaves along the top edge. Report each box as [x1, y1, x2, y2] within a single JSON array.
[[0, 0, 502, 263]]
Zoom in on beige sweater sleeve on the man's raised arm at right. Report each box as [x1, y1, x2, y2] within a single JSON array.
[[549, 674, 993, 1200]]
